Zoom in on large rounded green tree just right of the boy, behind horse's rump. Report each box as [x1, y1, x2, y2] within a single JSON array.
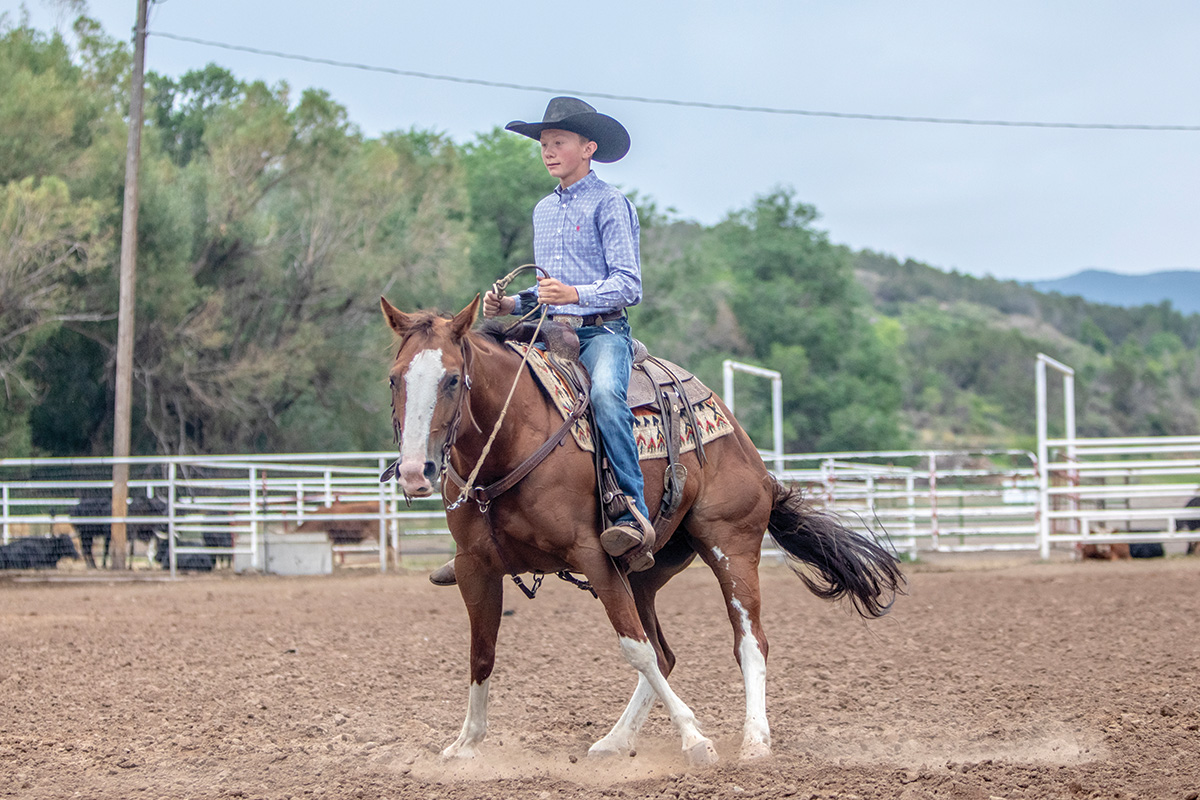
[[638, 190, 905, 451]]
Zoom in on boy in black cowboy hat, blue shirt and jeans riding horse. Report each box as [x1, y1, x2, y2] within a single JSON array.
[[430, 97, 654, 584]]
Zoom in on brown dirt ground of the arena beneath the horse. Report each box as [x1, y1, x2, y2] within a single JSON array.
[[0, 558, 1200, 800]]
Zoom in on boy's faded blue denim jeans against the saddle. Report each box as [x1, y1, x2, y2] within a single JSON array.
[[576, 319, 650, 522]]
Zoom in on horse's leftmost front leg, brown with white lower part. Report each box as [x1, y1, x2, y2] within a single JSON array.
[[442, 552, 504, 758]]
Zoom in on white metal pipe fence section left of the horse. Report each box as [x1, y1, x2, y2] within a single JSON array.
[[0, 453, 449, 573]]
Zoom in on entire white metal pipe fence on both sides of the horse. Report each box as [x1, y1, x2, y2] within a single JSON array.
[[0, 437, 1200, 573]]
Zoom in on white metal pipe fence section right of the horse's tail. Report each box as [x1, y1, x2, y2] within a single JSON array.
[[763, 448, 1200, 558]]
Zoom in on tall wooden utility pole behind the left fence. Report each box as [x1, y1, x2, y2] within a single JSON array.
[[112, 0, 148, 570]]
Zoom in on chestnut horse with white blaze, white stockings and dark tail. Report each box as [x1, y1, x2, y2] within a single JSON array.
[[380, 296, 904, 764]]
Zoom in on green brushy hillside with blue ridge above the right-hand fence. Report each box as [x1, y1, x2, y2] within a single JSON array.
[[848, 251, 1200, 449]]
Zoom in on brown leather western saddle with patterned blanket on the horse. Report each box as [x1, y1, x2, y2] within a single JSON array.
[[509, 321, 713, 533]]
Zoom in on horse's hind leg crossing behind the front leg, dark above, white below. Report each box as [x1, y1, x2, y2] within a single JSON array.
[[588, 551, 695, 756]]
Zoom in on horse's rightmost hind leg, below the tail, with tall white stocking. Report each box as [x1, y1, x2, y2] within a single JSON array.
[[700, 536, 770, 760]]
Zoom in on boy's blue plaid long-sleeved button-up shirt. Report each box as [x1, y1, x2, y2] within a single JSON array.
[[517, 172, 642, 315]]
